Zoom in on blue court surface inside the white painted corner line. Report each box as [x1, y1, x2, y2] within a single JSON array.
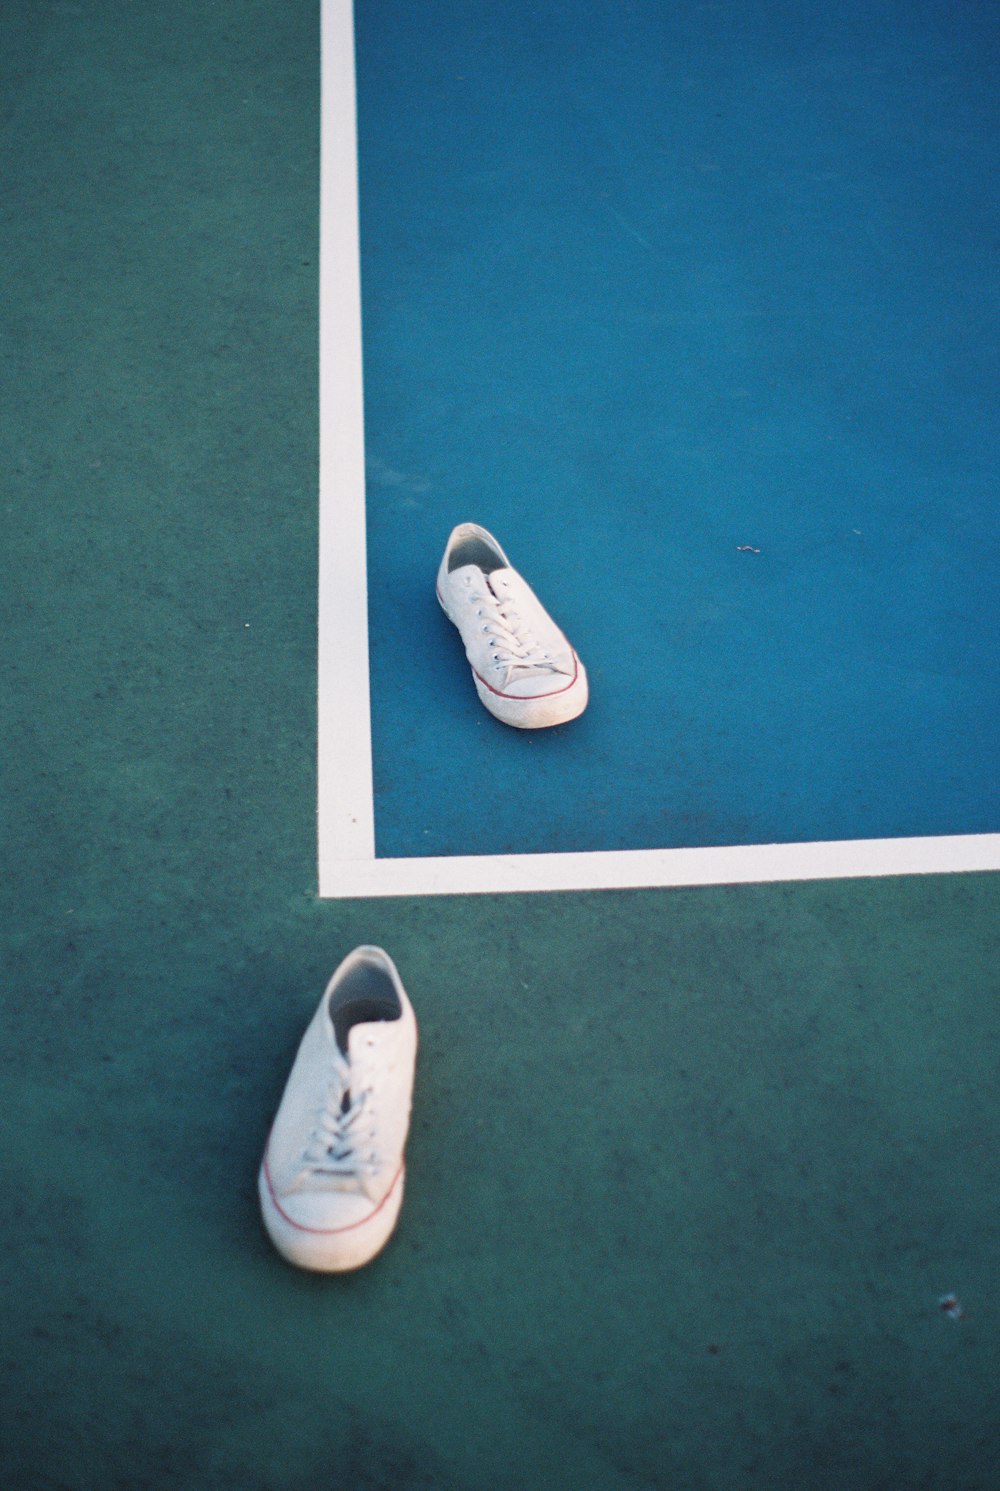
[[356, 0, 1000, 856]]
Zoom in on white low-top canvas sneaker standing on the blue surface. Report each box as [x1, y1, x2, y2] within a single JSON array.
[[438, 523, 587, 731]]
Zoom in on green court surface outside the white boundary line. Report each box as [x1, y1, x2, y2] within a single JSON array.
[[0, 0, 1000, 1491]]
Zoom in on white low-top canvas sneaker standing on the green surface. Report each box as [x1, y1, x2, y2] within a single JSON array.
[[259, 947, 417, 1273]]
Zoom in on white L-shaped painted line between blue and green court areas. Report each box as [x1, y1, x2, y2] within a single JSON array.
[[317, 0, 1000, 898]]
